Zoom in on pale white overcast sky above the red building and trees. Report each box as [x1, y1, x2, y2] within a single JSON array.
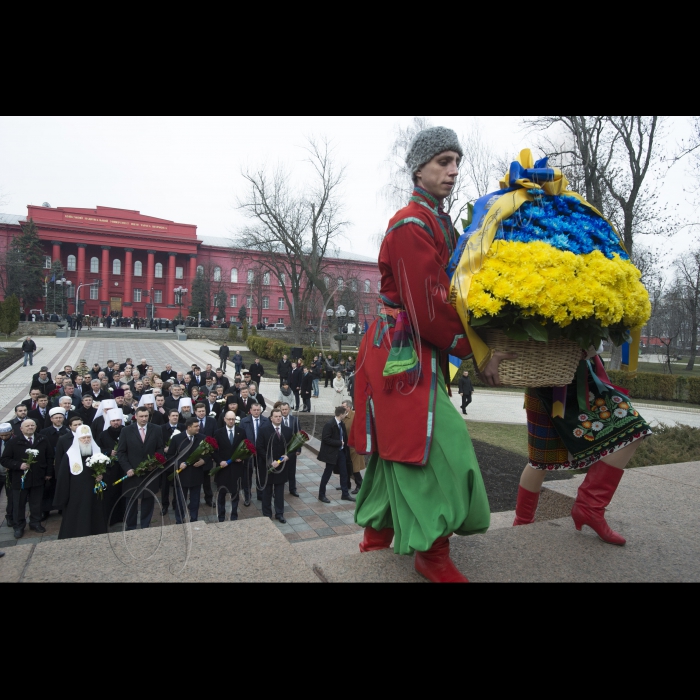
[[0, 116, 697, 262]]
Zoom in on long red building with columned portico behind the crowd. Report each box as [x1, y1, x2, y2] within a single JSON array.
[[0, 206, 380, 324]]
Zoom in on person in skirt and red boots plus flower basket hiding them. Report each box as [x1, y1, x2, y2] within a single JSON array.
[[448, 150, 651, 546]]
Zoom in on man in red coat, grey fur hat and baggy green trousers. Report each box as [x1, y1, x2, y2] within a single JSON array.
[[350, 127, 504, 583]]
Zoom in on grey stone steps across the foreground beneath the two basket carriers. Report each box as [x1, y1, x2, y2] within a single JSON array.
[[0, 462, 700, 583]]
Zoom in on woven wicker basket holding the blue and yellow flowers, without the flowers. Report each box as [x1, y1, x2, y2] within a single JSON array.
[[479, 329, 581, 387]]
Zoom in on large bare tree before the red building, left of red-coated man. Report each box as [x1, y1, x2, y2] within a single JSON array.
[[237, 139, 347, 342]]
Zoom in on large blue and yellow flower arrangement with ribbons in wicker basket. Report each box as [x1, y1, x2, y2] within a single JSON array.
[[449, 151, 651, 386]]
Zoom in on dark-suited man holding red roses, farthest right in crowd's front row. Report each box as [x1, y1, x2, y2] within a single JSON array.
[[255, 408, 292, 525]]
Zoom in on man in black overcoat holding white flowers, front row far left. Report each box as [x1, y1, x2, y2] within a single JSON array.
[[2, 418, 54, 540]]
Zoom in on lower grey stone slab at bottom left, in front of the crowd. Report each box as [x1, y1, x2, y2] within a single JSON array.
[[0, 518, 319, 583]]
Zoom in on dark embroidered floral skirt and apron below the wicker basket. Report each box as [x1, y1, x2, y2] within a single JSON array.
[[525, 372, 652, 471]]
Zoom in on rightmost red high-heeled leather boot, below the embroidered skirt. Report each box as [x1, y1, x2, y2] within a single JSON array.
[[571, 462, 627, 547]]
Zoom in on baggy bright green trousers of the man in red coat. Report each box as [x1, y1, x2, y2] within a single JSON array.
[[355, 372, 491, 555]]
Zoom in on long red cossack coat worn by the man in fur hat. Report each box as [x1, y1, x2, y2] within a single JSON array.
[[350, 189, 472, 466]]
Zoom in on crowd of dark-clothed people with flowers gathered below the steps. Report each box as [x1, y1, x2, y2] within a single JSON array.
[[0, 346, 364, 556]]
